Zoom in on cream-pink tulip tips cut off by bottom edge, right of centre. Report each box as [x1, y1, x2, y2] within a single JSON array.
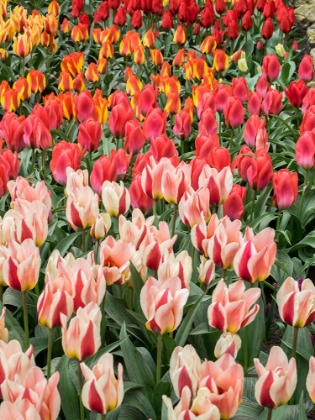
[[162, 387, 220, 420]]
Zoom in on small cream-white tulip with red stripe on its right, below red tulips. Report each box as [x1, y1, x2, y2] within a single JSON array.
[[102, 181, 130, 217]]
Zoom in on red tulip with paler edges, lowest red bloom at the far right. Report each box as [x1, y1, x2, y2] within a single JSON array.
[[272, 169, 298, 210]]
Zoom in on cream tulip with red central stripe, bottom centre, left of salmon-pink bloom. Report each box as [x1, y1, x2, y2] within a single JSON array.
[[170, 344, 201, 398]]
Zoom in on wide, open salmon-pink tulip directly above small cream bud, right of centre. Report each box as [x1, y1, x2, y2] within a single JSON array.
[[208, 279, 261, 333]]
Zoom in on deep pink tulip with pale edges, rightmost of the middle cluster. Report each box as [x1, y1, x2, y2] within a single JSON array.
[[233, 227, 277, 283]]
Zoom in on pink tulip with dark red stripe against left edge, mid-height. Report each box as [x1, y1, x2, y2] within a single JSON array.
[[3, 239, 41, 292]]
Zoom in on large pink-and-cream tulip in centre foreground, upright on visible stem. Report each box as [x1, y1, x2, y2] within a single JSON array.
[[140, 277, 189, 334]]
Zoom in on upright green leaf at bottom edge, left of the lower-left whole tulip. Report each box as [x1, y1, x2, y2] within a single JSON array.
[[56, 354, 80, 420]]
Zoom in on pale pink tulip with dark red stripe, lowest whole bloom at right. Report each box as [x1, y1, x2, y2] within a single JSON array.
[[254, 346, 297, 409]]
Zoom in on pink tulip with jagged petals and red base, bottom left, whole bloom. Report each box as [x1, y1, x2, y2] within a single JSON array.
[[80, 353, 124, 414]]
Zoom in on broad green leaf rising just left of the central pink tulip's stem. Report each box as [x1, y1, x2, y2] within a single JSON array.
[[120, 323, 155, 400]]
